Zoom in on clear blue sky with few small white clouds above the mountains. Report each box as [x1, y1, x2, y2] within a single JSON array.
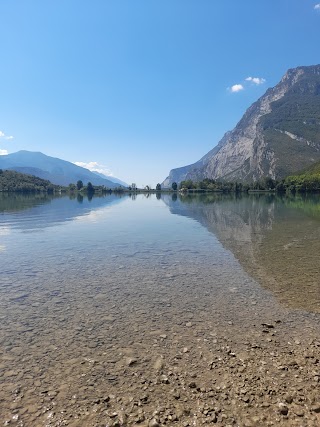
[[0, 0, 320, 186]]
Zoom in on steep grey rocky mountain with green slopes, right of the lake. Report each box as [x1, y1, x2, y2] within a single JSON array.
[[162, 65, 320, 187]]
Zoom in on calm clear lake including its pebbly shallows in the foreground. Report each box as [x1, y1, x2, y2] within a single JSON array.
[[0, 193, 320, 427]]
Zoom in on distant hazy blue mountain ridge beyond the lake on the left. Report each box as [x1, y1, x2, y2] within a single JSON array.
[[0, 150, 124, 188]]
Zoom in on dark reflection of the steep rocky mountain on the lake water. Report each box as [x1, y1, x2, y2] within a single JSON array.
[[164, 195, 320, 313]]
